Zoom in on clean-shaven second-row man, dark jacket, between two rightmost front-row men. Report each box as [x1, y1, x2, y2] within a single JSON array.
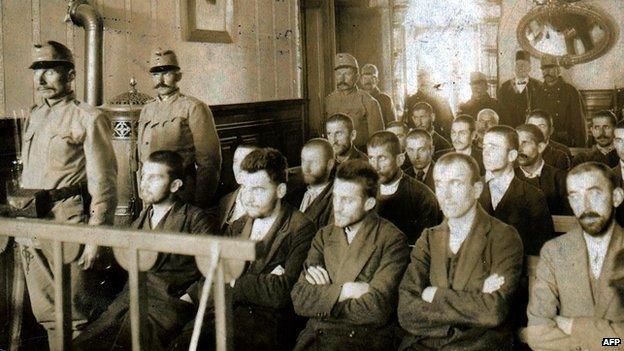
[[479, 126, 554, 256]]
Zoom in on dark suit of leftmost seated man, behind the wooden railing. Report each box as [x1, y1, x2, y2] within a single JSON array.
[[73, 202, 217, 351]]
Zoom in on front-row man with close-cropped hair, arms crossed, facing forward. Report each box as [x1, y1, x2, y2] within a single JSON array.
[[398, 152, 522, 350]]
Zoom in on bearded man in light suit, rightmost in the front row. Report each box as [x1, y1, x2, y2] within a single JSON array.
[[525, 162, 624, 350]]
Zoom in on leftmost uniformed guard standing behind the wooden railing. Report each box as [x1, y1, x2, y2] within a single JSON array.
[[19, 41, 117, 349]]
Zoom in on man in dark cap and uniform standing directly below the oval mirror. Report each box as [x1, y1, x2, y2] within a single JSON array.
[[536, 56, 587, 147]]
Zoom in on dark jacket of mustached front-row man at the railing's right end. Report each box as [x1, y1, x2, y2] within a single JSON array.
[[178, 202, 316, 350]]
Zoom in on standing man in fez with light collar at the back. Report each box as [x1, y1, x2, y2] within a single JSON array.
[[496, 50, 542, 127]]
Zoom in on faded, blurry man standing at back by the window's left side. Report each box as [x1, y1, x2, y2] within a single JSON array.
[[403, 69, 453, 139]]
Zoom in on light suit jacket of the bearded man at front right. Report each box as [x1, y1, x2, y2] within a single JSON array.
[[526, 225, 624, 350]]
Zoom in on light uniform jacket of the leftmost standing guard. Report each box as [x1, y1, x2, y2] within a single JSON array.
[[21, 94, 117, 225]]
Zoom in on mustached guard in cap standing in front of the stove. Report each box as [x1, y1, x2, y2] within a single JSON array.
[[137, 48, 221, 208]]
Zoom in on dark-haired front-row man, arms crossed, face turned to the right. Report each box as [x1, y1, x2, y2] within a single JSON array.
[[291, 160, 409, 351]]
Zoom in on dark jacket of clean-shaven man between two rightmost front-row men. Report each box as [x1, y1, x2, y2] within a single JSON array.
[[479, 177, 555, 256]]
